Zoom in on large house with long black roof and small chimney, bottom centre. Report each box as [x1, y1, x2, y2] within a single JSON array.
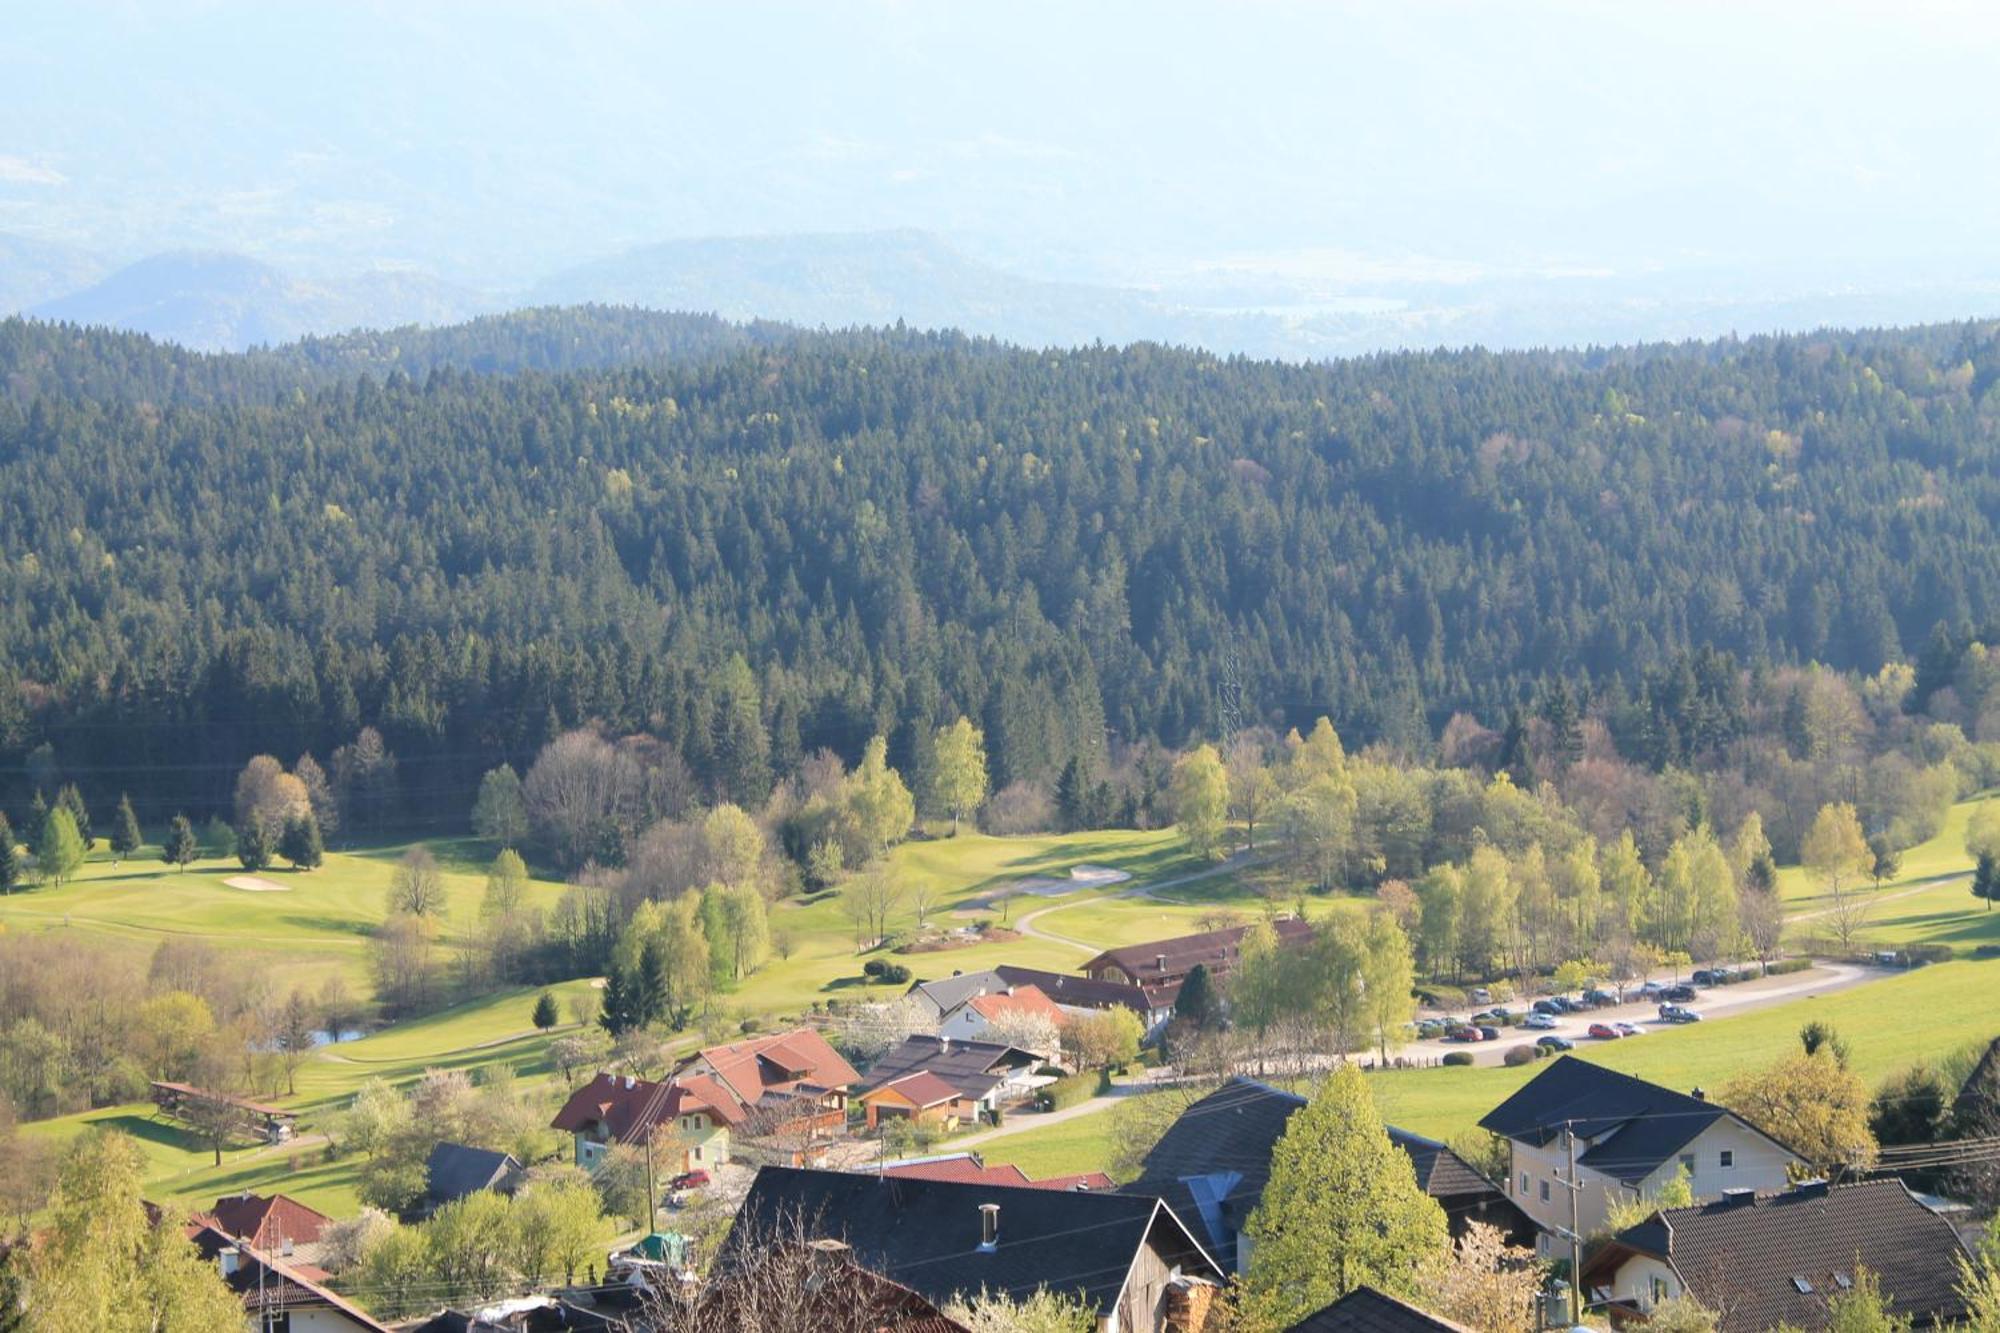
[[716, 1167, 1222, 1333]]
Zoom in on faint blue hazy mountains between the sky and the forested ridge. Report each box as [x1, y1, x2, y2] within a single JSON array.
[[11, 230, 2000, 360]]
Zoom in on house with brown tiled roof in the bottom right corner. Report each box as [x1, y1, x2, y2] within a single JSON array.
[[1584, 1179, 1968, 1333]]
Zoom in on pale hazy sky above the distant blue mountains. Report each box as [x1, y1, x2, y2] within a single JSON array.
[[0, 0, 2000, 284]]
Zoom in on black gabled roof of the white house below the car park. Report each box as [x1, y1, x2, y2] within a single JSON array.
[[1480, 1055, 1790, 1183]]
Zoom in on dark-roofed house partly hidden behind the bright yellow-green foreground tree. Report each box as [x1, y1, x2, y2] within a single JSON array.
[[1124, 1077, 1538, 1273]]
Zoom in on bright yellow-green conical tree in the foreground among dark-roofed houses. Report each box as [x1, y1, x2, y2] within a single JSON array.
[[1242, 1065, 1450, 1329]]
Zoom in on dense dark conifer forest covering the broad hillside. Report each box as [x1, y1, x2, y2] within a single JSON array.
[[0, 310, 2000, 823]]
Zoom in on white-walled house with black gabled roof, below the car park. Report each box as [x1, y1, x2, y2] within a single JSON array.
[[1480, 1055, 1800, 1253]]
